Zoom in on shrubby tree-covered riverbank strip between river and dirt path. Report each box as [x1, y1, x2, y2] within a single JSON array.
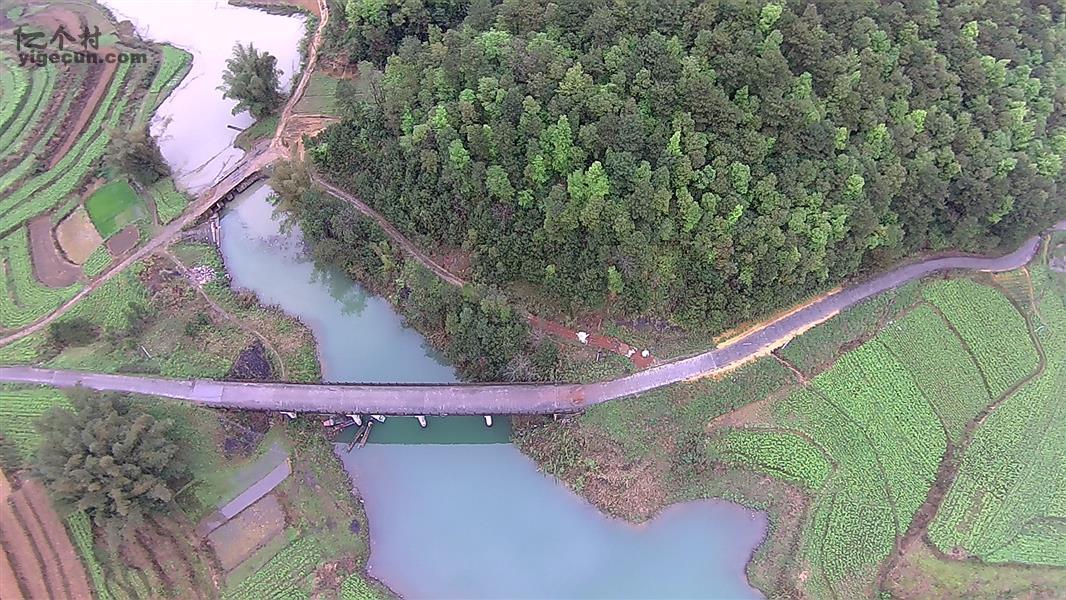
[[271, 175, 558, 382]]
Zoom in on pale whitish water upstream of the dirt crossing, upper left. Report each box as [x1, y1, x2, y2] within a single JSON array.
[[102, 0, 304, 192]]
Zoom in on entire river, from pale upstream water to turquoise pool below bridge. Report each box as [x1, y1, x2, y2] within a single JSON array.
[[107, 0, 766, 598]]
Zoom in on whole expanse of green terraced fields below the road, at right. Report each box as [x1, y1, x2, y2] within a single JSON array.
[[708, 270, 1053, 598]]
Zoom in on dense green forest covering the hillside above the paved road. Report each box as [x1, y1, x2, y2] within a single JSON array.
[[311, 0, 1066, 329]]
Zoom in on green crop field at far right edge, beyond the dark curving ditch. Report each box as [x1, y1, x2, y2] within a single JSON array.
[[930, 269, 1066, 566]]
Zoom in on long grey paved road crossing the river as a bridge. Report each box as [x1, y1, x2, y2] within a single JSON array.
[[0, 228, 1048, 415]]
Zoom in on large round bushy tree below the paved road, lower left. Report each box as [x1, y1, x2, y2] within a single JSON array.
[[35, 390, 185, 532]]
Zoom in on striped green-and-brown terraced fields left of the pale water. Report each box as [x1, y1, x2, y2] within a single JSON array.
[[0, 1, 191, 330]]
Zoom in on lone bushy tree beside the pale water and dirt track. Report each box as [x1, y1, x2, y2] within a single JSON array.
[[219, 44, 284, 118]]
